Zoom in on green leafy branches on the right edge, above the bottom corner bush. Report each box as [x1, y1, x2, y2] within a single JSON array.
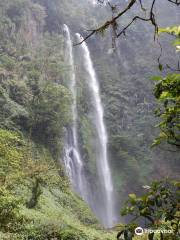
[[153, 26, 180, 149]]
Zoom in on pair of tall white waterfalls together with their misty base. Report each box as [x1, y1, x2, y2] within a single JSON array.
[[63, 25, 118, 227]]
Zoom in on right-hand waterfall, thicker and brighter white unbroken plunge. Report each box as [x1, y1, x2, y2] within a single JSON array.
[[76, 33, 115, 227]]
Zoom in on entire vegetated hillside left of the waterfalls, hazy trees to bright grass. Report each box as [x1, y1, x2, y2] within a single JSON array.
[[0, 0, 115, 240]]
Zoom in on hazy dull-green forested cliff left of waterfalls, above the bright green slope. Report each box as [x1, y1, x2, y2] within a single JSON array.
[[0, 1, 71, 157]]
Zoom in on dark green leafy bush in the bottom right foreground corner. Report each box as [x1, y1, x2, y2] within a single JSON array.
[[117, 180, 180, 240]]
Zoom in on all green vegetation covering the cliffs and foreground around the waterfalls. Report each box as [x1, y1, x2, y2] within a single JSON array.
[[0, 0, 180, 240]]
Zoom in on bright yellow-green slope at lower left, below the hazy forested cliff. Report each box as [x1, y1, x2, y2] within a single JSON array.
[[0, 129, 115, 240]]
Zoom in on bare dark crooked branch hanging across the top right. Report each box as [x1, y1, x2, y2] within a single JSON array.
[[77, 0, 180, 44]]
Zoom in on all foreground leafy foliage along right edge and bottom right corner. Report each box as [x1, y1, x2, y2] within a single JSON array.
[[117, 23, 180, 240]]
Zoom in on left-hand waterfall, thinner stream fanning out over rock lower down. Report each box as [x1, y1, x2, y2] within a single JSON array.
[[63, 25, 86, 199]]
